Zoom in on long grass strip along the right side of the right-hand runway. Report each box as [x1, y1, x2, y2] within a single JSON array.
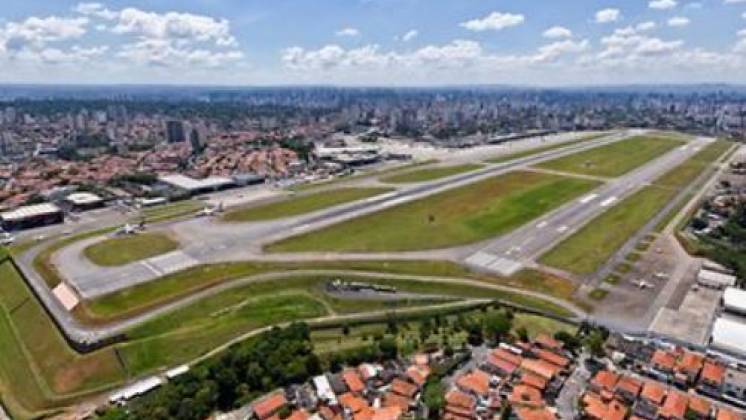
[[540, 141, 730, 274]]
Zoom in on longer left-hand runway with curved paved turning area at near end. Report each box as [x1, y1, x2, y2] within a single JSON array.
[[45, 130, 639, 299]]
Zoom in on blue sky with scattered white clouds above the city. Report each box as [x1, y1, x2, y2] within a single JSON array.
[[0, 0, 746, 86]]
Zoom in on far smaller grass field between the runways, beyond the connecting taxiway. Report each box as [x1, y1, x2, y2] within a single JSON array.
[[536, 136, 683, 178]]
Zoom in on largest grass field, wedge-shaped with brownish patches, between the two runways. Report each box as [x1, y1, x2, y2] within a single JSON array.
[[266, 172, 599, 252]]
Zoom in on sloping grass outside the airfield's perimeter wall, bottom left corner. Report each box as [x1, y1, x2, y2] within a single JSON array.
[[0, 263, 124, 417]]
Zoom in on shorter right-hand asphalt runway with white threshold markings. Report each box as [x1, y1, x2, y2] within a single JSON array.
[[466, 138, 713, 276]]
